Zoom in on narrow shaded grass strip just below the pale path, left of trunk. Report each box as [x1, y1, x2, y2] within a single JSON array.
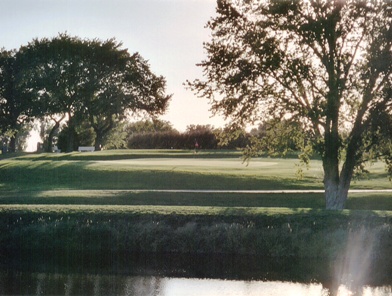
[[0, 190, 324, 208]]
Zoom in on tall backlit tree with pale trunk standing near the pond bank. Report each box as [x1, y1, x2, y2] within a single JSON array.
[[189, 0, 392, 209]]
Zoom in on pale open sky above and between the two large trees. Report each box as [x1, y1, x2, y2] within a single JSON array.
[[0, 0, 223, 131]]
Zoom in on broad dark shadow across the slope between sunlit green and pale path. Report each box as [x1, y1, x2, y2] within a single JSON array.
[[0, 157, 315, 195]]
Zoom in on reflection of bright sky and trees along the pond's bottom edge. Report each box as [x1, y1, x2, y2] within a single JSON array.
[[0, 271, 392, 296]]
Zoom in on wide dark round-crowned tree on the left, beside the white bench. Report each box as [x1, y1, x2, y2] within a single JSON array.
[[17, 34, 170, 151]]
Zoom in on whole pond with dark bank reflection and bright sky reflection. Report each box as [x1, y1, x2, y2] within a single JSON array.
[[0, 254, 392, 296]]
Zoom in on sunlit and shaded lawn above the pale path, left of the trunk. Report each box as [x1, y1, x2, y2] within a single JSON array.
[[0, 150, 322, 191]]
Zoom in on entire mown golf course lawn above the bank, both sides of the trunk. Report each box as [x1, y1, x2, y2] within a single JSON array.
[[0, 150, 392, 210]]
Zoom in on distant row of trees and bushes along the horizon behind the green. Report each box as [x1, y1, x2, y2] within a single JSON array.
[[47, 119, 305, 151]]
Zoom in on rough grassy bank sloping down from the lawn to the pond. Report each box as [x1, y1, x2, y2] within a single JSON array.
[[0, 205, 392, 259]]
